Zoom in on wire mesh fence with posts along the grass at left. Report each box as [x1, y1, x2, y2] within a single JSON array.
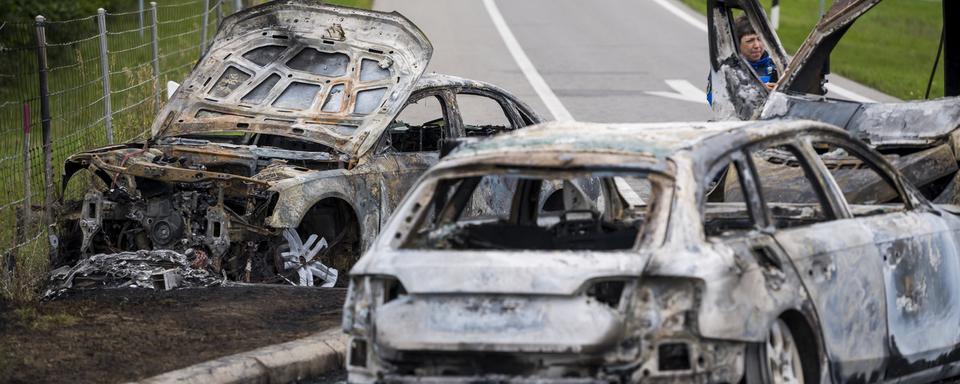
[[0, 0, 248, 297]]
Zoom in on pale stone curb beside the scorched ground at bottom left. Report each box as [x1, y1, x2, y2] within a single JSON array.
[[136, 327, 348, 384]]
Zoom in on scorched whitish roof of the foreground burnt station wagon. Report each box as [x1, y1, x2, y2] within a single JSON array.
[[445, 120, 849, 164]]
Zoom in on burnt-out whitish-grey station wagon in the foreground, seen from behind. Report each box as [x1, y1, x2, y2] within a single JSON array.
[[342, 121, 960, 383]]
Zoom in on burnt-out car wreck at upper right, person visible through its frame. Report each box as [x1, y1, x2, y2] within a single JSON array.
[[707, 0, 960, 204]]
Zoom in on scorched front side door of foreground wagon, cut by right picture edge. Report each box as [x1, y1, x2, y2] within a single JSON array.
[[807, 135, 960, 381]]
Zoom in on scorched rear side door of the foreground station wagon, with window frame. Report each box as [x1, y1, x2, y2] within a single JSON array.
[[744, 132, 900, 382]]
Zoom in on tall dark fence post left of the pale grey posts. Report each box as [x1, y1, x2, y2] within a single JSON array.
[[35, 16, 54, 224]]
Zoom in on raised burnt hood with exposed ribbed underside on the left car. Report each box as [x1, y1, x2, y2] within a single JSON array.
[[151, 0, 433, 156]]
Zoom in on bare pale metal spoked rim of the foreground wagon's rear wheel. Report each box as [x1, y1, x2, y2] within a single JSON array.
[[764, 319, 804, 384]]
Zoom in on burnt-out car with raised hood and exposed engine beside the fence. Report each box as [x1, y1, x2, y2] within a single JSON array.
[[53, 0, 541, 285]]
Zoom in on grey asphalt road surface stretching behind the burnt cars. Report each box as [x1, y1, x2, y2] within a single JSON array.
[[374, 0, 712, 122]]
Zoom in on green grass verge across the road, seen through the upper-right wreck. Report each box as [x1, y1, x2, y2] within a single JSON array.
[[682, 0, 943, 100]]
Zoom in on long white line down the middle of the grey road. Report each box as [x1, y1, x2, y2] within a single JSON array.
[[483, 0, 573, 121]]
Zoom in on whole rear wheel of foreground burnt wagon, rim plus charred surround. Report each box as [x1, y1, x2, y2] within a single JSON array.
[[744, 319, 810, 384]]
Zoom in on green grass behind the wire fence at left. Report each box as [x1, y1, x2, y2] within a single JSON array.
[[0, 0, 372, 302]]
